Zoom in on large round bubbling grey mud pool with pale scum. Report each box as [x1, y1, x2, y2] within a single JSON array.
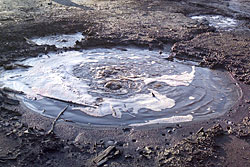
[[0, 47, 240, 126]]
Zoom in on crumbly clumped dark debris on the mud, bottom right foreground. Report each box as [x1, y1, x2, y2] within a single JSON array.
[[158, 124, 224, 166]]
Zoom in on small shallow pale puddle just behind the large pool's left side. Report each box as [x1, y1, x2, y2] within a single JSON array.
[[31, 32, 84, 48]]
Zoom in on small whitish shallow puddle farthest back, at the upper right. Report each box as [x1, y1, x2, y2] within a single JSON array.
[[191, 15, 238, 30]]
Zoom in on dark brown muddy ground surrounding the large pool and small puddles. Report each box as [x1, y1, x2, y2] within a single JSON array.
[[0, 0, 250, 167]]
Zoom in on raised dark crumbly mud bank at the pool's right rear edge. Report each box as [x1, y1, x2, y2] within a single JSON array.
[[172, 31, 250, 84]]
